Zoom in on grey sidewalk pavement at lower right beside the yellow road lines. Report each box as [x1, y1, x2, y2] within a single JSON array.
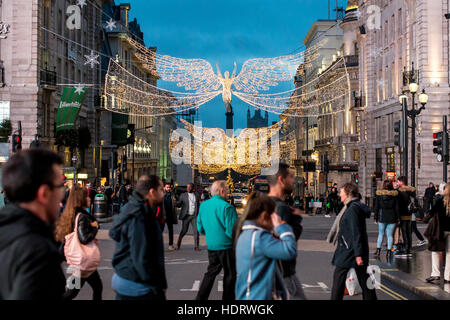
[[370, 245, 450, 300]]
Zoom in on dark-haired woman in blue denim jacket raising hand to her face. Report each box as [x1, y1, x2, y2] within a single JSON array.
[[236, 192, 297, 300]]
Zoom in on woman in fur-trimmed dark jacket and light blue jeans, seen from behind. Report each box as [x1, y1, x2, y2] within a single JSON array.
[[374, 180, 399, 259]]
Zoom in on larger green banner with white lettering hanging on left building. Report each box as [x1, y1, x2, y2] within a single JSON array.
[[56, 87, 86, 132]]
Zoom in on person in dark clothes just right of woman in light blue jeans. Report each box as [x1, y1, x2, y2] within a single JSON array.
[[395, 176, 416, 258]]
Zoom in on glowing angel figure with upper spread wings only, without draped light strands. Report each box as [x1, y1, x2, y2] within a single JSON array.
[[123, 38, 328, 110]]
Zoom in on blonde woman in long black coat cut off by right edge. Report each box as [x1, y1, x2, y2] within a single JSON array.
[[423, 183, 450, 284]]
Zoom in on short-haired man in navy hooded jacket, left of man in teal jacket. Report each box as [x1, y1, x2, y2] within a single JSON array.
[[109, 175, 167, 300]]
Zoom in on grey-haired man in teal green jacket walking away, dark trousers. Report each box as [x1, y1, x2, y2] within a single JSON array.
[[196, 180, 237, 301]]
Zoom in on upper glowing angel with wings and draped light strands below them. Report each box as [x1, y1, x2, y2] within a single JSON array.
[[105, 38, 351, 117]]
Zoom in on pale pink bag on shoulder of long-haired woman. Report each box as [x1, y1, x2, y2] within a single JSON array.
[[64, 213, 100, 278]]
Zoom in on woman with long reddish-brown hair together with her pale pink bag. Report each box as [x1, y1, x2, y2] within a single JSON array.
[[55, 185, 103, 300]]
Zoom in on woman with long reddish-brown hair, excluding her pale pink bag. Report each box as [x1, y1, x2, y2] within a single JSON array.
[[55, 185, 103, 300]]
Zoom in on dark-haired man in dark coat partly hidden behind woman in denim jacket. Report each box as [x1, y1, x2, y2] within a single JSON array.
[[268, 163, 306, 300]]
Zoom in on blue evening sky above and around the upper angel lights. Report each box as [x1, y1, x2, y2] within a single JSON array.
[[128, 0, 347, 129]]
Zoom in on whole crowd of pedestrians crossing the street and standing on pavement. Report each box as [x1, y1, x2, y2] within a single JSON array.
[[0, 149, 450, 301]]
